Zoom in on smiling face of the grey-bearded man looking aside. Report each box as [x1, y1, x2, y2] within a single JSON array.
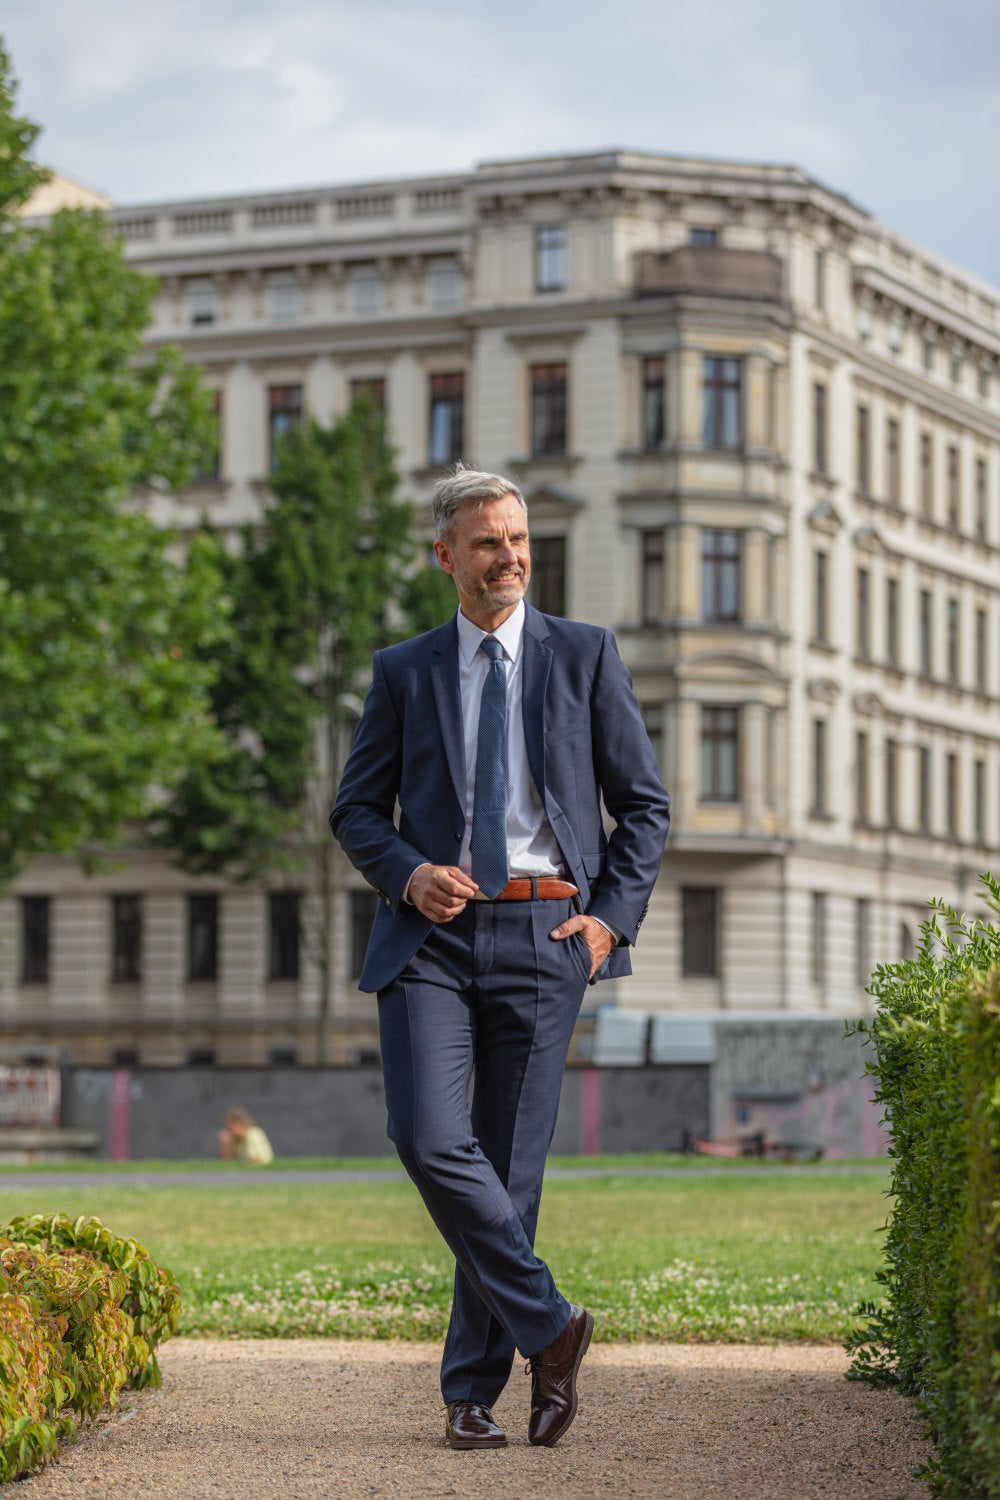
[[435, 495, 531, 630]]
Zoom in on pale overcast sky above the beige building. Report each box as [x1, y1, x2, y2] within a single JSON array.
[[0, 0, 1000, 284]]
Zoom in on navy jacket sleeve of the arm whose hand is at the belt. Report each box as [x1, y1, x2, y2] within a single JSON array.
[[330, 651, 426, 912]]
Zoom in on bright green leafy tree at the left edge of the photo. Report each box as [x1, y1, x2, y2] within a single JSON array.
[[0, 47, 225, 887]]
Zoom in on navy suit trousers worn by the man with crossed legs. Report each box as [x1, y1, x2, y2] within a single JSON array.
[[378, 900, 591, 1406]]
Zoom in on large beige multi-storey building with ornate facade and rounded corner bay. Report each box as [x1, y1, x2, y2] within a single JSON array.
[[0, 152, 1000, 1061]]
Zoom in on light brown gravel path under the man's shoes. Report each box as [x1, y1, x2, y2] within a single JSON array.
[[19, 1338, 928, 1500]]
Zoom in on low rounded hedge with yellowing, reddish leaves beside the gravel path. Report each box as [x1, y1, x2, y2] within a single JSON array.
[[0, 1214, 180, 1481]]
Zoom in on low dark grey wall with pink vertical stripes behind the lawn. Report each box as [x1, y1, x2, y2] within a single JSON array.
[[63, 1064, 709, 1160]]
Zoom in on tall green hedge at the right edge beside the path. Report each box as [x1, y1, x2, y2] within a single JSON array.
[[849, 876, 1000, 1500]]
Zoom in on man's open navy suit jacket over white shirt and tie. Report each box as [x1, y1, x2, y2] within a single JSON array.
[[330, 606, 670, 990]]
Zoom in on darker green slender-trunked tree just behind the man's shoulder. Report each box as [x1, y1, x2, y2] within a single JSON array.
[[157, 398, 454, 1062]]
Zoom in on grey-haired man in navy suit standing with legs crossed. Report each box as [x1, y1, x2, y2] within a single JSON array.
[[330, 468, 669, 1448]]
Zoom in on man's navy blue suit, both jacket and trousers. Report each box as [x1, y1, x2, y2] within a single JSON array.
[[330, 606, 669, 1406]]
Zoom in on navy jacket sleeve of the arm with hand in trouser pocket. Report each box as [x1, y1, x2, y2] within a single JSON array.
[[588, 630, 670, 944]]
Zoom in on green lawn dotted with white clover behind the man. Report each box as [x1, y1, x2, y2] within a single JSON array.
[[0, 1158, 888, 1343]]
